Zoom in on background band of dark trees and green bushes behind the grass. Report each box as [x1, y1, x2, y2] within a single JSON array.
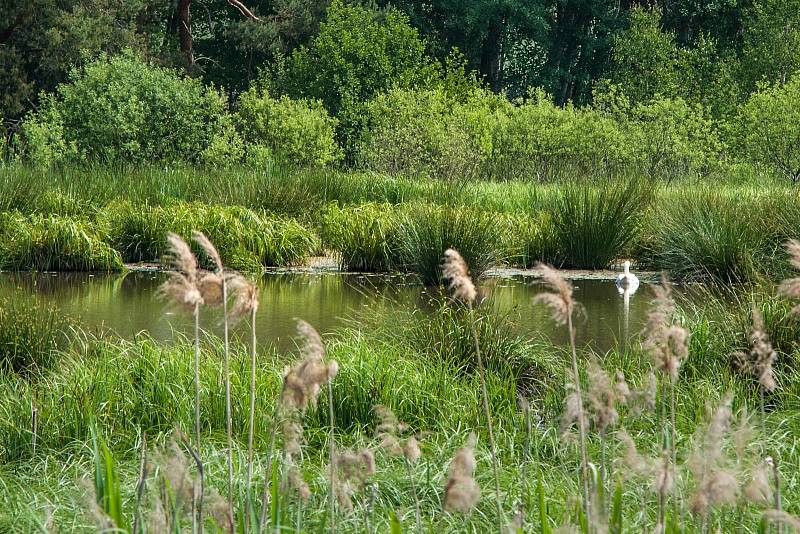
[[0, 0, 800, 180]]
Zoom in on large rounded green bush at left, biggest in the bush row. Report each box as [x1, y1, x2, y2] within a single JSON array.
[[22, 54, 229, 164]]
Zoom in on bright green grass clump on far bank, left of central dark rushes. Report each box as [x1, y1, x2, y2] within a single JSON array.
[[321, 204, 399, 272]]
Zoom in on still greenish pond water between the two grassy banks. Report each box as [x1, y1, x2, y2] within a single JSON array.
[[0, 272, 652, 352]]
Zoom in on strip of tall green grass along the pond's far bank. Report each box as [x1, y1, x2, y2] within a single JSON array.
[[0, 167, 800, 283]]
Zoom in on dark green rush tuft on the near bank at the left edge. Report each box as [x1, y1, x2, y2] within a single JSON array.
[[0, 298, 72, 374]]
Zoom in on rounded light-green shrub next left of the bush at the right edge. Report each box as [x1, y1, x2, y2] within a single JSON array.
[[624, 98, 723, 178]]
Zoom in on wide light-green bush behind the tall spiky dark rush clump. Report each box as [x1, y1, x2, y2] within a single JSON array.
[[491, 90, 628, 179]]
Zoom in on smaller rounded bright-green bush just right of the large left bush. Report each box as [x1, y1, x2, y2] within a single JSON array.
[[237, 87, 339, 166]]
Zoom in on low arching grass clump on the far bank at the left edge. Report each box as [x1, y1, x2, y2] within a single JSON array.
[[0, 213, 123, 271]]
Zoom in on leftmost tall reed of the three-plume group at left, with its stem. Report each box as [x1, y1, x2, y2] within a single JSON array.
[[159, 232, 205, 532]]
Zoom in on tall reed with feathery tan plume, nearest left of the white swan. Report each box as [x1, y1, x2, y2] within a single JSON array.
[[533, 264, 591, 517]]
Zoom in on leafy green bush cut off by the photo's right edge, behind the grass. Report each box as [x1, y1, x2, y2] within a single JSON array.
[[735, 77, 800, 183]]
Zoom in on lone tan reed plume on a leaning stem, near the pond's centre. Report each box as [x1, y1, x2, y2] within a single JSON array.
[[442, 249, 505, 532]]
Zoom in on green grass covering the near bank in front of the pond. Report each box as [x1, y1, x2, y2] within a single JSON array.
[[0, 284, 800, 532]]
